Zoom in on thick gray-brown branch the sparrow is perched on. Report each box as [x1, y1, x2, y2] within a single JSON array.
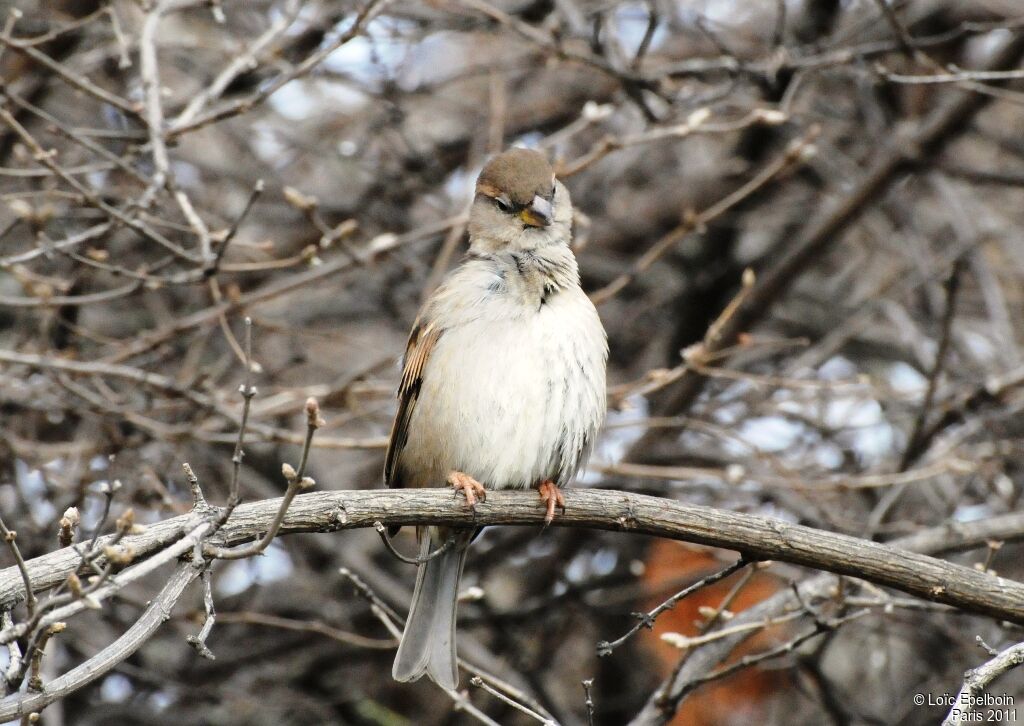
[[0, 488, 1024, 624]]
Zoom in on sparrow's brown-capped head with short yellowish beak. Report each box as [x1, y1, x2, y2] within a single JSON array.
[[469, 148, 572, 252]]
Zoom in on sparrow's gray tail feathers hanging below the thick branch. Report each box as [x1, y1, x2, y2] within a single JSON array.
[[391, 527, 469, 690]]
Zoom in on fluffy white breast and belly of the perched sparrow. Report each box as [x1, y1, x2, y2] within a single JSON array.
[[401, 287, 607, 488]]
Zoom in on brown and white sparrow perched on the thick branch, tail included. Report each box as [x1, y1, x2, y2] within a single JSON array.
[[384, 147, 608, 690]]
